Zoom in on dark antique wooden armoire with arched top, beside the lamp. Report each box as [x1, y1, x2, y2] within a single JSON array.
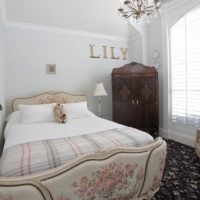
[[112, 62, 159, 136]]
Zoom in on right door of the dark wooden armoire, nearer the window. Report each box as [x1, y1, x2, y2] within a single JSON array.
[[134, 76, 158, 131]]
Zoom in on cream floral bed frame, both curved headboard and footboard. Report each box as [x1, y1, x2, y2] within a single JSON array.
[[0, 92, 166, 200]]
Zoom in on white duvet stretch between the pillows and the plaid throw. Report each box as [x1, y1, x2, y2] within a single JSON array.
[[4, 115, 124, 150]]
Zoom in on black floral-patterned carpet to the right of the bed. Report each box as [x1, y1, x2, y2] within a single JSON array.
[[153, 140, 200, 200]]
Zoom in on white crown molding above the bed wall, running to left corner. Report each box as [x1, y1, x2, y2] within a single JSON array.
[[0, 0, 130, 42]]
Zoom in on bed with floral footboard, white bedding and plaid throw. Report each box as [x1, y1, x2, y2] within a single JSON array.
[[0, 92, 166, 200]]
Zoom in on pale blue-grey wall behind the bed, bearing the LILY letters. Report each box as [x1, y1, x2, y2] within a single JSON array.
[[5, 27, 130, 118]]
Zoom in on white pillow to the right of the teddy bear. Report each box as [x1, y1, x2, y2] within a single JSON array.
[[63, 101, 94, 119]]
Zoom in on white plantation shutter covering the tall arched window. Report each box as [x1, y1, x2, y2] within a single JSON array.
[[170, 9, 200, 127]]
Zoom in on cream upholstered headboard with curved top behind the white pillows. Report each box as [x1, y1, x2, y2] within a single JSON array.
[[12, 92, 87, 111]]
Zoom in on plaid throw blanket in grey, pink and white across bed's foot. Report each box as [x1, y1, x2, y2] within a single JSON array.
[[0, 127, 153, 176]]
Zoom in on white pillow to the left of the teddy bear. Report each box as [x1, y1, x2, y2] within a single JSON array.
[[19, 103, 56, 124]]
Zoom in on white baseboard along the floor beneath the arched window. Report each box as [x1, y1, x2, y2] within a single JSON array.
[[160, 128, 196, 147]]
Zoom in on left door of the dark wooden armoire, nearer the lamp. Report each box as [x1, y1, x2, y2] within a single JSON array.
[[113, 77, 134, 126]]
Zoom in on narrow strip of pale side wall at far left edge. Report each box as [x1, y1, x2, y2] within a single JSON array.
[[0, 6, 5, 154]]
